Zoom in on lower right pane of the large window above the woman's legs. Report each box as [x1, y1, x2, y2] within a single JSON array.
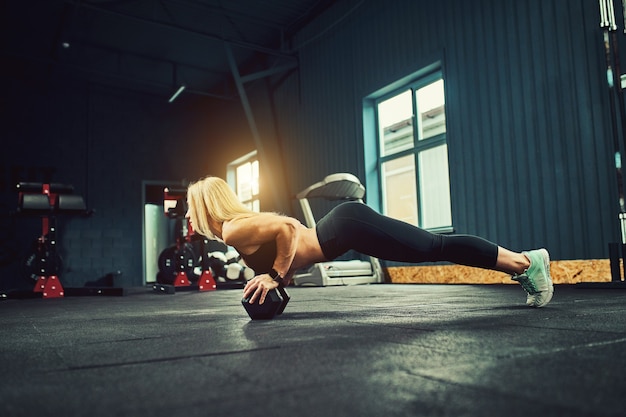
[[418, 145, 452, 229]]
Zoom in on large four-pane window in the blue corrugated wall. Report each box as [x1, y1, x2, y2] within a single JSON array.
[[365, 72, 452, 231]]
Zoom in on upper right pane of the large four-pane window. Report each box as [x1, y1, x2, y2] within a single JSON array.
[[415, 79, 446, 140]]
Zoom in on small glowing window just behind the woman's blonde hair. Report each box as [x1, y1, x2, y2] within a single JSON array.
[[227, 151, 261, 212]]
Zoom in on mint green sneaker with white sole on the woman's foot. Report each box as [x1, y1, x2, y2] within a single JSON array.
[[511, 249, 554, 307]]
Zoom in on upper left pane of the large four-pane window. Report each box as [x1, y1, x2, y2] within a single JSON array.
[[378, 90, 413, 156]]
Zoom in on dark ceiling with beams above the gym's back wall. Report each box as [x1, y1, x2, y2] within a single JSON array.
[[2, 0, 336, 99]]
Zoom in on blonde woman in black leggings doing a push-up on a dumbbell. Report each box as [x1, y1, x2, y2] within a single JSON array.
[[186, 177, 554, 307]]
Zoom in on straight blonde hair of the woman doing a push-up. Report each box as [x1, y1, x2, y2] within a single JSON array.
[[187, 176, 257, 238]]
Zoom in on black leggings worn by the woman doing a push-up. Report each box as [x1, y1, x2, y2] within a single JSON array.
[[316, 202, 498, 268]]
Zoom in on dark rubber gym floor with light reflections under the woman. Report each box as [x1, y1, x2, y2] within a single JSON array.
[[0, 284, 626, 417]]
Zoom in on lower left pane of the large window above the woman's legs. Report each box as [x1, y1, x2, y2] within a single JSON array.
[[382, 155, 418, 226]]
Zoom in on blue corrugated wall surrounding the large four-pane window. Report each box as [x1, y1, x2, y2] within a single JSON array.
[[252, 0, 618, 259]]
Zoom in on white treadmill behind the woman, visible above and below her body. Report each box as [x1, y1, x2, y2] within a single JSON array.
[[293, 173, 383, 286]]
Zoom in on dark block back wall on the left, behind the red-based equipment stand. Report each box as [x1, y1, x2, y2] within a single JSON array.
[[0, 76, 254, 290]]
